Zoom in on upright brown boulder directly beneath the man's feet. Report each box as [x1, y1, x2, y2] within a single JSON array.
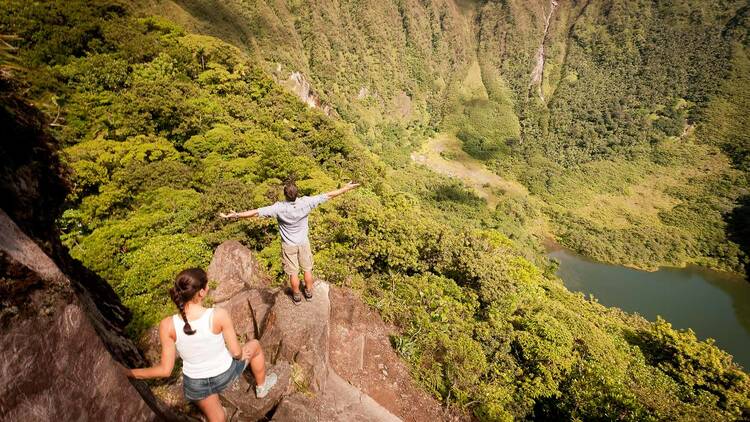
[[260, 281, 331, 393]]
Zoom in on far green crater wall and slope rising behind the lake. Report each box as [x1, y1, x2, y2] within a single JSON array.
[[147, 0, 748, 272]]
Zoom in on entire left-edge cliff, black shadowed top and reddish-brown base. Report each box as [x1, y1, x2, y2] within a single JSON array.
[[0, 87, 173, 420]]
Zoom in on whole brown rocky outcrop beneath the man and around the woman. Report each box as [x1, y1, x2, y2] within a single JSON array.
[[143, 241, 463, 422]]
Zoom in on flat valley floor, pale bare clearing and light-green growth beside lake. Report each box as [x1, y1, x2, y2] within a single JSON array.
[[411, 130, 748, 271]]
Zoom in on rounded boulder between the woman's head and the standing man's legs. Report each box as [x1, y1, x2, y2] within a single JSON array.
[[207, 240, 268, 303]]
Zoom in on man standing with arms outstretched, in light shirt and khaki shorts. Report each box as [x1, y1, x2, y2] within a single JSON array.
[[219, 182, 359, 304]]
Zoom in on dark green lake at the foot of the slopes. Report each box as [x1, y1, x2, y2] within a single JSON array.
[[548, 248, 750, 371]]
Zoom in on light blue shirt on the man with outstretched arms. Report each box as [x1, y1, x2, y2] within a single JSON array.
[[258, 193, 328, 245]]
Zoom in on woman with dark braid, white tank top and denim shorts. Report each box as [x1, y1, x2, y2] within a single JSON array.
[[127, 268, 277, 422]]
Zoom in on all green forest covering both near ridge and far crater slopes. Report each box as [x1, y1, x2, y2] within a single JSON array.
[[0, 0, 750, 420]]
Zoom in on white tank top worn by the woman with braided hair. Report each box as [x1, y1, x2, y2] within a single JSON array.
[[172, 308, 232, 378]]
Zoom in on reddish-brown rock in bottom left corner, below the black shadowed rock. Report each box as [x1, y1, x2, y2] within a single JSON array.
[[0, 210, 157, 421]]
